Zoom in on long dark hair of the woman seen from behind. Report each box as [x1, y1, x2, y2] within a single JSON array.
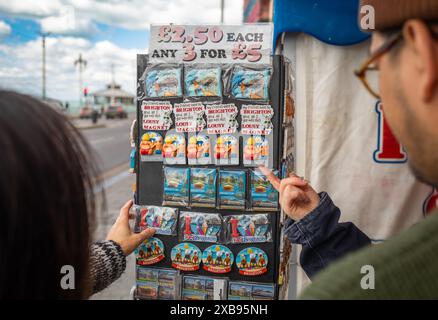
[[0, 90, 98, 299]]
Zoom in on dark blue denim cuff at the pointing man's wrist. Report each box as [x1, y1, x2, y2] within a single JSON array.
[[284, 192, 371, 278]]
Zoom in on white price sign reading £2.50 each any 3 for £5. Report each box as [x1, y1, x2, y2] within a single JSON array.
[[149, 23, 272, 64]]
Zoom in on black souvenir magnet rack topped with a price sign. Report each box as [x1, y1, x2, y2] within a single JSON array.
[[134, 24, 293, 300]]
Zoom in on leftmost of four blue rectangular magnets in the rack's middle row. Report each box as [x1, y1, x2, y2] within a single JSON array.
[[163, 167, 189, 206]]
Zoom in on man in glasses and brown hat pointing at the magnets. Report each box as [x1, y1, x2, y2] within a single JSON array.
[[266, 0, 438, 299]]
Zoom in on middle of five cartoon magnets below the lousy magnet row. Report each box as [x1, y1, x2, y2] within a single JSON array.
[[187, 133, 211, 165]]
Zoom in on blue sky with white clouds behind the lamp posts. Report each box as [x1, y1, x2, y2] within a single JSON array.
[[0, 0, 243, 101]]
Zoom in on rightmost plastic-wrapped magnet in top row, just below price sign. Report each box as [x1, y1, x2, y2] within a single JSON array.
[[230, 66, 271, 101]]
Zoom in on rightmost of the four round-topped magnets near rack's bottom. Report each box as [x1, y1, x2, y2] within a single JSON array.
[[236, 247, 268, 276]]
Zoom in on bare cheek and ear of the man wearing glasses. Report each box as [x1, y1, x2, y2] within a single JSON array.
[[371, 22, 438, 186]]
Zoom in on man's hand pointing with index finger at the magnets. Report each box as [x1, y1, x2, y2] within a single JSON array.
[[259, 167, 319, 221]]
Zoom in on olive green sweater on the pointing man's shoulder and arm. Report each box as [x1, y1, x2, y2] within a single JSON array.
[[301, 213, 438, 299]]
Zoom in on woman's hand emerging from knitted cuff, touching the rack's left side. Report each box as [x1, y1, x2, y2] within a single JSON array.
[[106, 200, 155, 255]]
